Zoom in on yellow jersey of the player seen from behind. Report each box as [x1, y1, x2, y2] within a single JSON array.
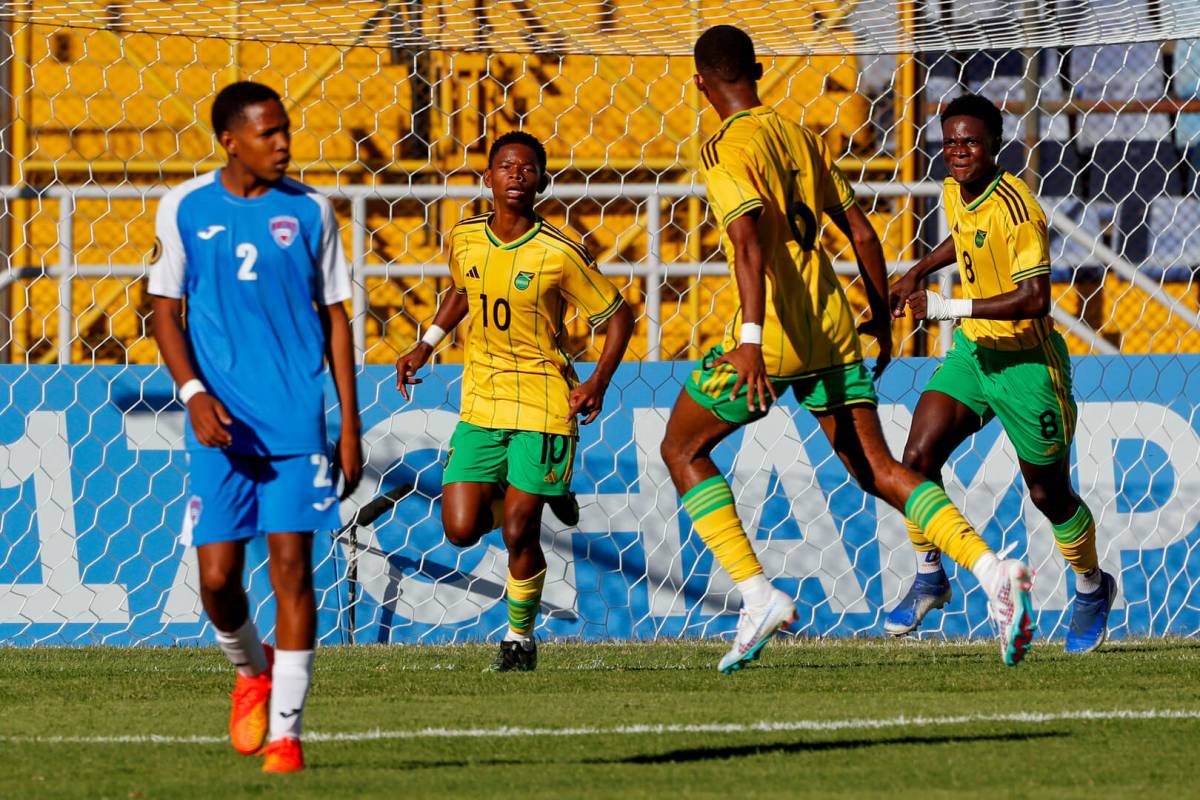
[[701, 106, 863, 378]]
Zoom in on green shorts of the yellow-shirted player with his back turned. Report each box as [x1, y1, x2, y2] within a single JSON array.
[[684, 345, 878, 425]]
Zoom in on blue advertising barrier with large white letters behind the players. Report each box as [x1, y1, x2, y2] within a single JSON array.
[[0, 355, 1200, 645]]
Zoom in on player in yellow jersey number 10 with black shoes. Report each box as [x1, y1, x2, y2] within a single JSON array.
[[396, 132, 634, 672]]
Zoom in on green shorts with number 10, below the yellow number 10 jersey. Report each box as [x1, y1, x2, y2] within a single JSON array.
[[442, 422, 578, 497]]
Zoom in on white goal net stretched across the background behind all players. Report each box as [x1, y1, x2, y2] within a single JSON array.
[[0, 0, 1200, 644]]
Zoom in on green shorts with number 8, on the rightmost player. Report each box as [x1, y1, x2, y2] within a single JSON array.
[[925, 330, 1076, 464]]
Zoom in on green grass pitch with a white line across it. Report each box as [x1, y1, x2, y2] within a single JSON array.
[[0, 639, 1200, 800]]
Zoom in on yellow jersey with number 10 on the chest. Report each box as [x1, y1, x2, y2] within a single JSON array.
[[450, 215, 623, 435]]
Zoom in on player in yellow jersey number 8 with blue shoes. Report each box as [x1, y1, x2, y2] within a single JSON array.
[[884, 95, 1116, 652]]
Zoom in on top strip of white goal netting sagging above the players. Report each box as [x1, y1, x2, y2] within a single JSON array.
[[5, 0, 1200, 55]]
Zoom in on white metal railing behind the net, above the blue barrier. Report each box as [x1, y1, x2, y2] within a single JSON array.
[[0, 181, 1152, 363]]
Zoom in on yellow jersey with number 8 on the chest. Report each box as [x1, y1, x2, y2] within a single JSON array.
[[942, 170, 1054, 350]]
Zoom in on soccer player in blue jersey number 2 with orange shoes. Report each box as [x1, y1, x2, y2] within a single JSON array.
[[150, 82, 362, 772]]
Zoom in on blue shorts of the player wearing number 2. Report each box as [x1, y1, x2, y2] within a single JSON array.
[[184, 447, 342, 546]]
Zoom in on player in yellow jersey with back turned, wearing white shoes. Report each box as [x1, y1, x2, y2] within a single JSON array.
[[662, 25, 1033, 673]]
